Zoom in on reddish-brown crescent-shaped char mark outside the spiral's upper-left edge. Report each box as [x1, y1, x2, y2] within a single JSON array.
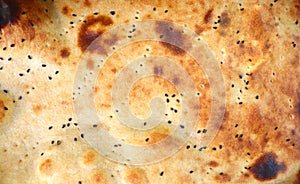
[[78, 15, 113, 52]]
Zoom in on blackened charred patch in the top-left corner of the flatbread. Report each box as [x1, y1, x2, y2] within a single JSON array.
[[0, 0, 21, 29]]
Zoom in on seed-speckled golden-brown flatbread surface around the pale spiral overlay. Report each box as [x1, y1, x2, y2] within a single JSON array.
[[0, 0, 300, 184]]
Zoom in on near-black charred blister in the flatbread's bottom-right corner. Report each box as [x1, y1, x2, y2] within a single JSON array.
[[250, 153, 286, 181]]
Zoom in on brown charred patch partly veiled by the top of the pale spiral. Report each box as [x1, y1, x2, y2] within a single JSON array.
[[155, 22, 190, 55]]
